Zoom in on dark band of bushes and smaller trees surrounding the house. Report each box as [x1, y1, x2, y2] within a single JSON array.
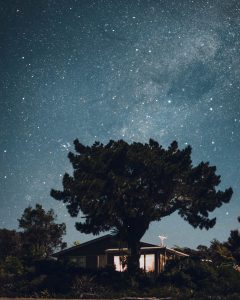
[[0, 205, 240, 299]]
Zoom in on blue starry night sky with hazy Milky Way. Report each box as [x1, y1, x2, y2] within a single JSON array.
[[0, 0, 240, 247]]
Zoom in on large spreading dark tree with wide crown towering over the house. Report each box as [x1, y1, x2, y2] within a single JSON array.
[[51, 139, 232, 272]]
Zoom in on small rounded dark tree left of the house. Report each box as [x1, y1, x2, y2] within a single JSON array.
[[18, 204, 66, 259]]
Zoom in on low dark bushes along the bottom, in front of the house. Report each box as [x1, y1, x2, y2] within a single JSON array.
[[0, 260, 240, 299]]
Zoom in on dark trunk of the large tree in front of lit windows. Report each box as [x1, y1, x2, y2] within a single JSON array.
[[127, 239, 140, 275]]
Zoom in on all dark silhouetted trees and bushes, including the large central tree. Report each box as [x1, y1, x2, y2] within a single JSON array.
[[0, 140, 240, 299]]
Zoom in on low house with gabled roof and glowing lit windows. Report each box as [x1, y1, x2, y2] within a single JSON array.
[[53, 234, 188, 274]]
